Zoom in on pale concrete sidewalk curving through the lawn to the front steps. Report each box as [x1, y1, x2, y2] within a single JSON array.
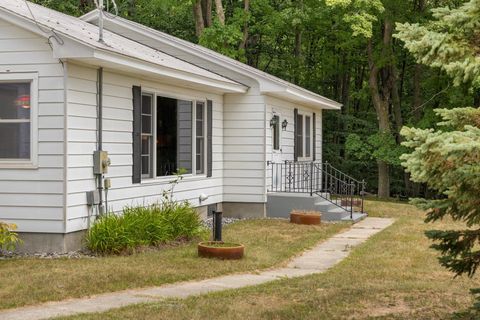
[[0, 218, 394, 320]]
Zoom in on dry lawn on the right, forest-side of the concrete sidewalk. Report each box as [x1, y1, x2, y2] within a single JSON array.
[[59, 201, 480, 320]]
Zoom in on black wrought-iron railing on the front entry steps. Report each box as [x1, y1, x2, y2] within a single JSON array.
[[267, 161, 365, 218]]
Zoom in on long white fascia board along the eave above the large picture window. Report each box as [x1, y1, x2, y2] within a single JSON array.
[[93, 50, 248, 93]]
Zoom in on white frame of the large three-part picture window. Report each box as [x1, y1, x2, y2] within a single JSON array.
[[138, 87, 208, 183]]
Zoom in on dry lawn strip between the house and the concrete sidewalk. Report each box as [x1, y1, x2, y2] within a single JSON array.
[[0, 220, 348, 309]]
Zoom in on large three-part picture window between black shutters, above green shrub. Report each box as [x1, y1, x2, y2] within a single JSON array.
[[142, 93, 206, 178]]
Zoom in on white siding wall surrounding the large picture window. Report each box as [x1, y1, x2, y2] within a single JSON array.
[[67, 63, 223, 232]]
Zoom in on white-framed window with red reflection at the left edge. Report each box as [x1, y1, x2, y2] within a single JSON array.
[[0, 74, 37, 167]]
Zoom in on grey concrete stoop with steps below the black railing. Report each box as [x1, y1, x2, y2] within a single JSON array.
[[267, 192, 367, 223]]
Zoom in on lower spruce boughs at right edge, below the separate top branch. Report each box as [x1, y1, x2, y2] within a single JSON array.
[[401, 108, 480, 276]]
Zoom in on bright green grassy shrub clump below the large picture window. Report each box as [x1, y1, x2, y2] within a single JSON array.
[[86, 201, 202, 254]]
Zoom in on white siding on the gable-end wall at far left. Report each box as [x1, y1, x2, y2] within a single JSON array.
[[0, 20, 65, 233]]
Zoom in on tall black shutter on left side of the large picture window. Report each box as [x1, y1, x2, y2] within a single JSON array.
[[132, 86, 142, 183]]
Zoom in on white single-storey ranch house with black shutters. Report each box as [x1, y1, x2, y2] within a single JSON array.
[[0, 0, 364, 251]]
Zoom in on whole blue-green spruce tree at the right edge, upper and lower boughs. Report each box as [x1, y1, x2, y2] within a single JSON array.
[[396, 0, 480, 310]]
